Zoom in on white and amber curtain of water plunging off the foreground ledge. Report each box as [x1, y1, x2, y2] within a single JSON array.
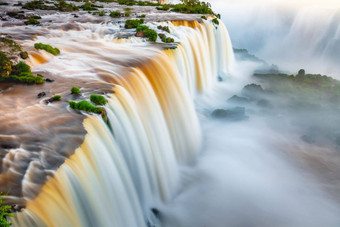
[[13, 21, 233, 227]]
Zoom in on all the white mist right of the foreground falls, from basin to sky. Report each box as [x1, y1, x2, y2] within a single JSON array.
[[159, 0, 340, 224]]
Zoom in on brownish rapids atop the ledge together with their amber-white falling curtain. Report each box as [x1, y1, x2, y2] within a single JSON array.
[[1, 3, 233, 223]]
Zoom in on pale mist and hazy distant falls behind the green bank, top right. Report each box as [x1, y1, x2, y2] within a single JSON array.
[[209, 0, 340, 78]]
